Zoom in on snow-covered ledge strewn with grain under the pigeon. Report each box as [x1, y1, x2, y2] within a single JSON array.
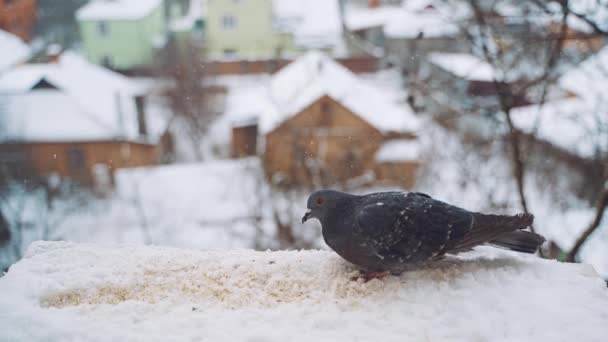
[[0, 242, 608, 341]]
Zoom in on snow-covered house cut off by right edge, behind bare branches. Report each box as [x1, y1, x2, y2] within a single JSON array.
[[511, 47, 608, 201]]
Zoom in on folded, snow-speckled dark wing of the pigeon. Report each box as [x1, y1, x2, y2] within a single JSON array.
[[354, 193, 472, 262]]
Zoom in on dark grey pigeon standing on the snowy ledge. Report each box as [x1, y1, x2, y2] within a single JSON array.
[[302, 190, 545, 280]]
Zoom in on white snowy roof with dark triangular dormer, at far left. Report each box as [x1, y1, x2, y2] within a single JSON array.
[[0, 52, 164, 141]]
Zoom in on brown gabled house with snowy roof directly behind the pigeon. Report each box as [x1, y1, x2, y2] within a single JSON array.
[[233, 52, 420, 187]]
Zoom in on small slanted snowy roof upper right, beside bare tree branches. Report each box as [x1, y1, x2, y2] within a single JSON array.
[[428, 52, 502, 82]]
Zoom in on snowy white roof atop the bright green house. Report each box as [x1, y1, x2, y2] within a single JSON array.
[[76, 0, 163, 20]]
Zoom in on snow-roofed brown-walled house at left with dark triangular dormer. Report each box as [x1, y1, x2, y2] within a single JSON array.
[[0, 52, 166, 187]]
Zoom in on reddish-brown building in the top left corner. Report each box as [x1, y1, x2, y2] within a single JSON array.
[[0, 0, 36, 41]]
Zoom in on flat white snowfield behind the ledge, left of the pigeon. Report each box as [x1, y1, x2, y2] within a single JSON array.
[[53, 158, 268, 249]]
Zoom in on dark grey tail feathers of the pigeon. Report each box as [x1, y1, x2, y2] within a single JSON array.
[[452, 213, 545, 253]]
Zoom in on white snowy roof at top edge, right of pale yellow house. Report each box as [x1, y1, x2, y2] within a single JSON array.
[[272, 0, 342, 49]]
